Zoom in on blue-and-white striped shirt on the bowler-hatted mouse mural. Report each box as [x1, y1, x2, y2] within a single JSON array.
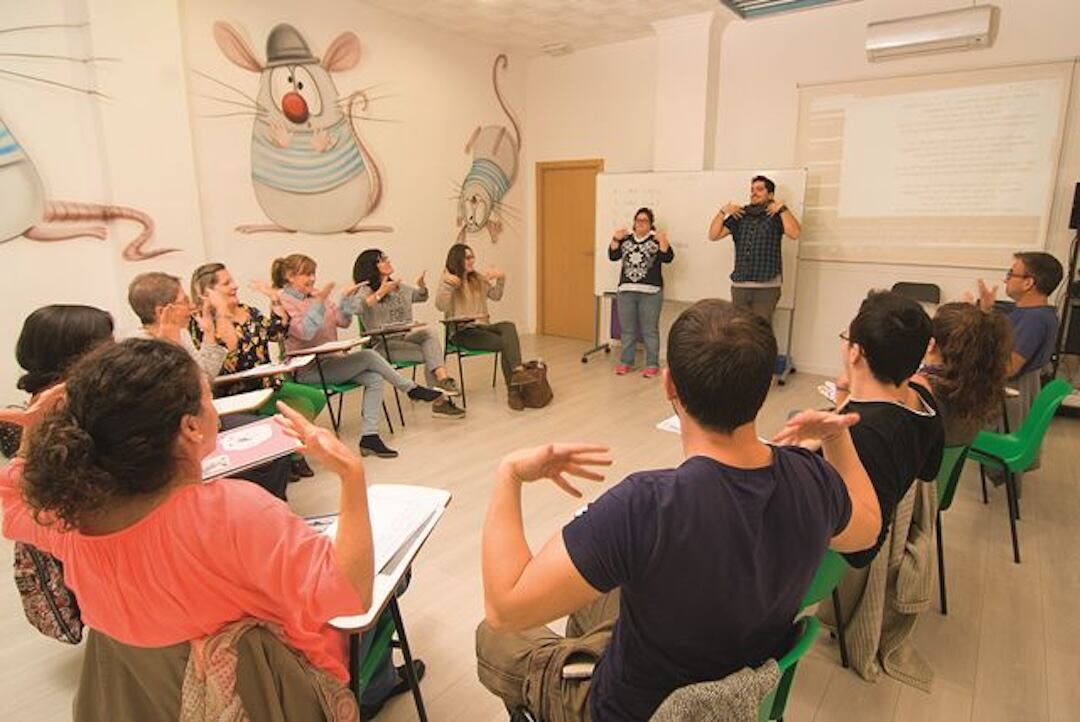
[[252, 118, 364, 193]]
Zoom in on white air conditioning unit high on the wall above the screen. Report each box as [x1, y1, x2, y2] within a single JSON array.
[[866, 5, 997, 62]]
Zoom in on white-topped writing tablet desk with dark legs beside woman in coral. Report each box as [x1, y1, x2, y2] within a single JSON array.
[[330, 485, 451, 722]]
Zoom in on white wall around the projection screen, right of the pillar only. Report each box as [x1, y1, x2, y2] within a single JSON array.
[[716, 0, 1080, 371]]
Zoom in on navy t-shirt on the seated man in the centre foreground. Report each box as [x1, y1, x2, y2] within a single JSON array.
[[563, 447, 851, 722]]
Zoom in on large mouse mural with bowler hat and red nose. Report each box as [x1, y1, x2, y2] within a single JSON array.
[[214, 22, 393, 233]]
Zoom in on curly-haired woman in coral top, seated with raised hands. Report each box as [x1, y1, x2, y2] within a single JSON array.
[[0, 339, 419, 704]]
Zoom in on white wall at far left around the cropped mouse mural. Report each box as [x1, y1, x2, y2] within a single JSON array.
[[0, 0, 202, 404]]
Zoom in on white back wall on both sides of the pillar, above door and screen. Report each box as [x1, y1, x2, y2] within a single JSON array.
[[528, 0, 1080, 372]]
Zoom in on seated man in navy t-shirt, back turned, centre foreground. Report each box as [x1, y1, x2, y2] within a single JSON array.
[[476, 300, 881, 722]]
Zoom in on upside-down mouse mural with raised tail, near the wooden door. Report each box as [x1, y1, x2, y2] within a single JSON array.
[[458, 54, 522, 243]]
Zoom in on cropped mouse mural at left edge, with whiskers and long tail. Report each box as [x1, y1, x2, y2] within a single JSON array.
[[0, 24, 177, 261]]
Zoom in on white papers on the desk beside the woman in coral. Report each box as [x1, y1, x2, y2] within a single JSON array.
[[308, 483, 450, 574]]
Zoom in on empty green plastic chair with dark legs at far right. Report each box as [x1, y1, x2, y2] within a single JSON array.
[[968, 379, 1072, 564]]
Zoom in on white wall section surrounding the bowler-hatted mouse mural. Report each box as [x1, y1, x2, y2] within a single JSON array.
[[181, 0, 530, 334]]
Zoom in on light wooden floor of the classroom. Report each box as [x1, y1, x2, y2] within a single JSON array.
[[0, 337, 1080, 722]]
